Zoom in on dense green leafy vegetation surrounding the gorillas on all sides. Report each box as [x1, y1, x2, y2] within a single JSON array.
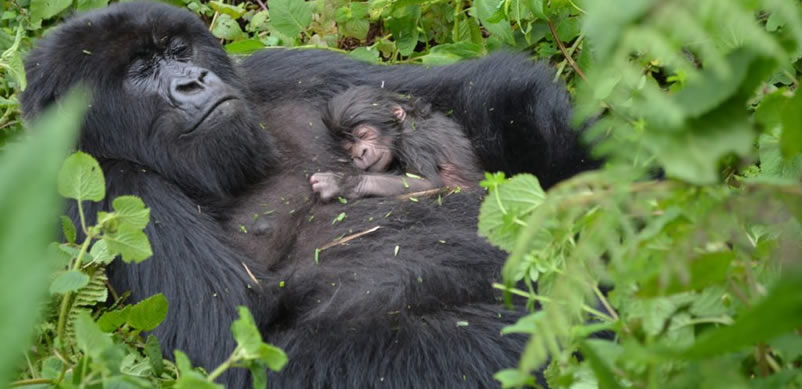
[[0, 0, 802, 388]]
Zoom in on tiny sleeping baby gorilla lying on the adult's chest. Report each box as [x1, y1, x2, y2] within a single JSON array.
[[309, 86, 483, 200]]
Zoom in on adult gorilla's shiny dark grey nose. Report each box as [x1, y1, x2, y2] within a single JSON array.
[[170, 69, 225, 109]]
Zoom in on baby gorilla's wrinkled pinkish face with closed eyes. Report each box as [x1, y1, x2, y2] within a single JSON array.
[[342, 124, 393, 172]]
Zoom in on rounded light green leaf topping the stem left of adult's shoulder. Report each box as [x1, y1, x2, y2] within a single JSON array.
[[58, 151, 106, 201]]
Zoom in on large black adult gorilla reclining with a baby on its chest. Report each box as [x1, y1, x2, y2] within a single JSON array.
[[22, 3, 587, 388]]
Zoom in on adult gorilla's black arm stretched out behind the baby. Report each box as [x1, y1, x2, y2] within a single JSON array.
[[241, 50, 597, 187]]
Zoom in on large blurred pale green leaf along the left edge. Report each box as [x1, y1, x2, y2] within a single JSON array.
[[0, 87, 87, 387]]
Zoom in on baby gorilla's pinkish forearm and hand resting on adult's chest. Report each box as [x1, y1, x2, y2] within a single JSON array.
[[309, 172, 435, 201]]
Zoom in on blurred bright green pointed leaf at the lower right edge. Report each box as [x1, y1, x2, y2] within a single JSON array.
[[679, 272, 802, 359]]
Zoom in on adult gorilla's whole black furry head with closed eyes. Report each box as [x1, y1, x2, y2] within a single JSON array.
[[22, 3, 273, 197]]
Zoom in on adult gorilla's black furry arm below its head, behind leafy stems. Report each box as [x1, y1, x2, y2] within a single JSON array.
[[68, 161, 271, 387]]
